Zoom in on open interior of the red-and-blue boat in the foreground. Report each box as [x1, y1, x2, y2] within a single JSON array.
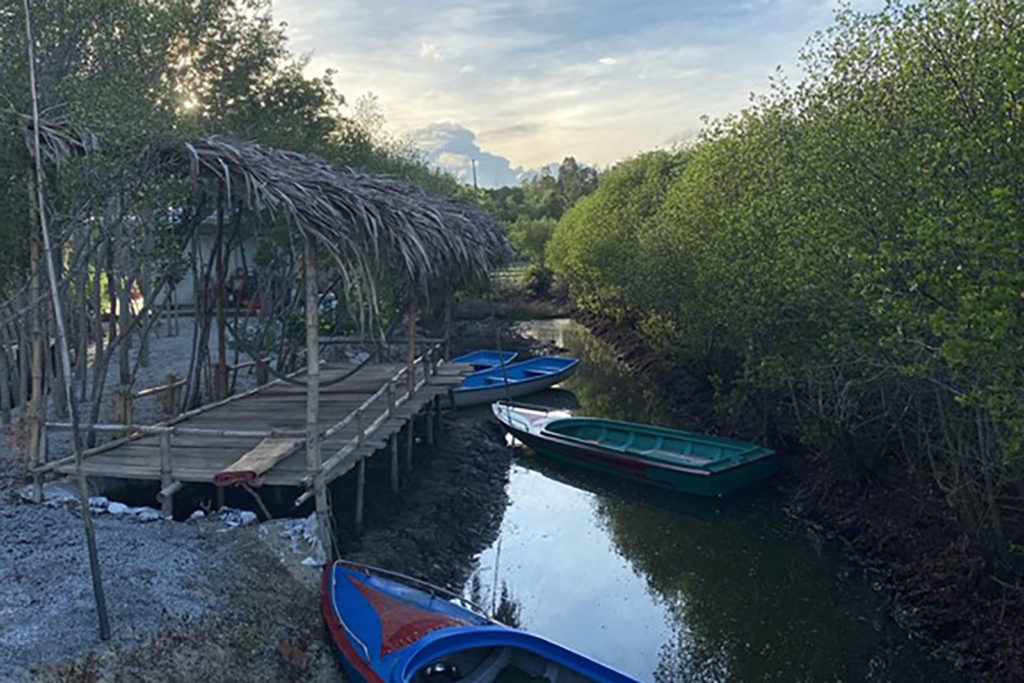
[[412, 646, 594, 683]]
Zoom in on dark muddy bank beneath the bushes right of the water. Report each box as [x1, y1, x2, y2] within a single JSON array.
[[575, 313, 1024, 681]]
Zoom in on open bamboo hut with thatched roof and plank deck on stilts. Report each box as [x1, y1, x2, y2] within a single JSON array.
[[12, 131, 510, 553]]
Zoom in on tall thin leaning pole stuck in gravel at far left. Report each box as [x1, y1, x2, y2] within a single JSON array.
[[23, 0, 111, 640]]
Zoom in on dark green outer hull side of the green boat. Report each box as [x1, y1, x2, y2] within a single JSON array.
[[495, 408, 778, 497]]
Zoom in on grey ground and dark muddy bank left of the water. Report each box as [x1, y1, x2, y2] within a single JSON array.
[[0, 319, 545, 682]]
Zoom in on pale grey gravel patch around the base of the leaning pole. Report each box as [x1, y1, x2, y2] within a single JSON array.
[[0, 503, 225, 679]]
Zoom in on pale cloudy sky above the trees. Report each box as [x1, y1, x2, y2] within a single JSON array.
[[273, 0, 883, 186]]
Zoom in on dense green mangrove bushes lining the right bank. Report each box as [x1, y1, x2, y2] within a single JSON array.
[[547, 0, 1024, 551]]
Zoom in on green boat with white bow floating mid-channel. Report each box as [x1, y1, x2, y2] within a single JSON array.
[[492, 402, 778, 496]]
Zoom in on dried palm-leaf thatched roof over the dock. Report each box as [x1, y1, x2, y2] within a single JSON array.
[[32, 119, 512, 305]]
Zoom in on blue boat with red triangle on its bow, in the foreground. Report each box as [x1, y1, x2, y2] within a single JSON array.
[[323, 560, 636, 683]]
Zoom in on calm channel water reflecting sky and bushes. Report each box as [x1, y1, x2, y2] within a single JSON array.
[[466, 321, 959, 683]]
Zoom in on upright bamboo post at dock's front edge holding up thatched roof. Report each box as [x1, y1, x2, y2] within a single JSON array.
[[302, 234, 333, 559]]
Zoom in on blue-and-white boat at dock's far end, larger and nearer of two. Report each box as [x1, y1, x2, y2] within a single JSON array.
[[452, 355, 580, 405]]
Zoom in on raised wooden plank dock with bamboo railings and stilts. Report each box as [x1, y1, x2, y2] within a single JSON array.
[[37, 354, 472, 519]]
